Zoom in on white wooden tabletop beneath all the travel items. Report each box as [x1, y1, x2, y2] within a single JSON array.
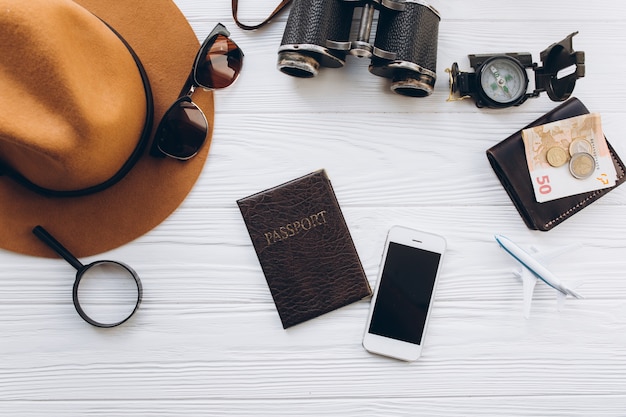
[[0, 0, 626, 417]]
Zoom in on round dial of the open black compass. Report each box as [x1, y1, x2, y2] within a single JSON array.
[[479, 56, 528, 104]]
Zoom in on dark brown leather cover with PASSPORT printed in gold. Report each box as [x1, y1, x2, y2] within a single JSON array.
[[237, 170, 371, 329]]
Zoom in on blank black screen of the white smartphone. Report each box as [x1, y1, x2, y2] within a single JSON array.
[[369, 242, 441, 345]]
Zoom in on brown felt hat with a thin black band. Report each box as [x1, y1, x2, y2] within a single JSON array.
[[0, 0, 214, 257]]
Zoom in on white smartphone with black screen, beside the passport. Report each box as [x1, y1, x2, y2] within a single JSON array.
[[363, 226, 446, 361]]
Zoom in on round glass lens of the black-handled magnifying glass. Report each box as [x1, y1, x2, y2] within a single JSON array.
[[77, 261, 140, 324]]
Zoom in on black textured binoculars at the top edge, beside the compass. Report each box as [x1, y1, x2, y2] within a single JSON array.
[[278, 0, 441, 97]]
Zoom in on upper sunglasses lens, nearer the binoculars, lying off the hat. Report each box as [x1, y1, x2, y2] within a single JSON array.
[[194, 34, 243, 89]]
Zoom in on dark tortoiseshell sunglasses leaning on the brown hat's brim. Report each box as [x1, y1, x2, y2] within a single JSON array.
[[150, 23, 243, 161]]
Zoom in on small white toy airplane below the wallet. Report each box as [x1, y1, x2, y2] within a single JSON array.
[[495, 235, 583, 318]]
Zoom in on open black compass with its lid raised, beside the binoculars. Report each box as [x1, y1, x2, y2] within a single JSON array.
[[446, 32, 585, 108]]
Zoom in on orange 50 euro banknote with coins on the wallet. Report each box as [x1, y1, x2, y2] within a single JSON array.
[[522, 113, 617, 203]]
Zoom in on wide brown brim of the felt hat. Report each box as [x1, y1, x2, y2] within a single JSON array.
[[0, 0, 214, 257]]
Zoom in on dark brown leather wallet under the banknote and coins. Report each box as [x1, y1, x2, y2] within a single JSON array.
[[487, 98, 624, 231]]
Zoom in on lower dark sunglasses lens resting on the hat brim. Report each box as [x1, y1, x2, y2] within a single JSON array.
[[155, 96, 209, 160]]
